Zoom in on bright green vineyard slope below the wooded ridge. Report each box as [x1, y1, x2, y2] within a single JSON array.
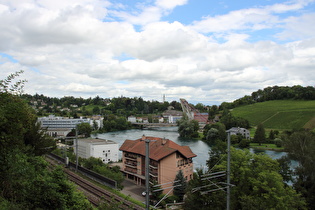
[[232, 100, 315, 130]]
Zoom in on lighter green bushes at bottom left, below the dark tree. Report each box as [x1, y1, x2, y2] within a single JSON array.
[[0, 149, 91, 209]]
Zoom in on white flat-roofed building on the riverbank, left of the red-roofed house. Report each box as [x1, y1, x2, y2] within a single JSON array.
[[74, 138, 118, 163]]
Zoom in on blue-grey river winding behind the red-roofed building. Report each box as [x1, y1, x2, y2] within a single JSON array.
[[93, 127, 296, 169]]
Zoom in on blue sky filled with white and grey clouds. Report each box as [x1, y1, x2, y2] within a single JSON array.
[[0, 0, 315, 106]]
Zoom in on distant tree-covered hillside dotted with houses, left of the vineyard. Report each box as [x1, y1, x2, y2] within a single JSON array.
[[22, 94, 181, 118]]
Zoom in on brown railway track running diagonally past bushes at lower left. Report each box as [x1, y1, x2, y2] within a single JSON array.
[[49, 157, 145, 210]]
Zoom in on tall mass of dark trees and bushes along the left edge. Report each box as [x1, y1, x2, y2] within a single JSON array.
[[0, 74, 91, 209]]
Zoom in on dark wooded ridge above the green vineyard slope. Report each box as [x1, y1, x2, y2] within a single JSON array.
[[221, 85, 315, 109]]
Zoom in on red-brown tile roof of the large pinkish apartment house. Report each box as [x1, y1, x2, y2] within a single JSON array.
[[119, 136, 197, 161]]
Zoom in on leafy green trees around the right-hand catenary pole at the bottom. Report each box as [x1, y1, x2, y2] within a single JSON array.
[[185, 148, 306, 209]]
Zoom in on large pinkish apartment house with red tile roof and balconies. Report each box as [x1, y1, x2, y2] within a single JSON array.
[[119, 136, 197, 193]]
